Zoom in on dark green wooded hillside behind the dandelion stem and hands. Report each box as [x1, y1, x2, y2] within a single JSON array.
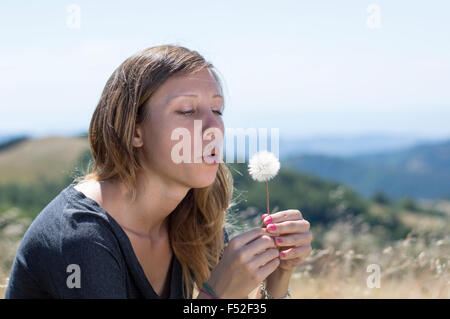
[[227, 164, 420, 245]]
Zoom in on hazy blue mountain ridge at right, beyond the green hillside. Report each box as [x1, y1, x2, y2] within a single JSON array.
[[284, 140, 450, 199]]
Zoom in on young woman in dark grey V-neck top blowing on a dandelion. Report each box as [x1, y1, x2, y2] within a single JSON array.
[[6, 45, 312, 298]]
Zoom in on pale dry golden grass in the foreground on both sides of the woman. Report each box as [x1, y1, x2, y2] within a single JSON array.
[[0, 210, 450, 299]]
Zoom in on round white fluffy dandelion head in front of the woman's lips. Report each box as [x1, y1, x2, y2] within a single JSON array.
[[248, 151, 280, 182]]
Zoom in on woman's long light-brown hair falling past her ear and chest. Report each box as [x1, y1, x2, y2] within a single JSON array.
[[75, 45, 233, 299]]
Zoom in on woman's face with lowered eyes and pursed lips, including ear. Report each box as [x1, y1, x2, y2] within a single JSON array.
[[133, 69, 224, 188]]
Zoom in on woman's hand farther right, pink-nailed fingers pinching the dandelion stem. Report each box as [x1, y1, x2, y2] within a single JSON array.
[[263, 209, 313, 271]]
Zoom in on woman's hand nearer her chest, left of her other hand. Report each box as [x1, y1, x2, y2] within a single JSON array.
[[208, 227, 280, 299]]
